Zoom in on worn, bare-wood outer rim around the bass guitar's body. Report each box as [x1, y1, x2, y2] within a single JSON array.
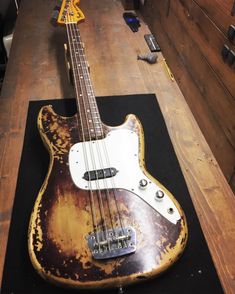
[[28, 106, 188, 289]]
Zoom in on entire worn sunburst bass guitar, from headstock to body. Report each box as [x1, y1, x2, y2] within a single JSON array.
[[28, 0, 187, 289]]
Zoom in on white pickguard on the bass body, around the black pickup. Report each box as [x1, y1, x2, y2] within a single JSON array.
[[69, 129, 181, 224]]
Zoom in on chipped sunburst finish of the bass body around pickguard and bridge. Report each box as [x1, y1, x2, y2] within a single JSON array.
[[28, 106, 187, 289]]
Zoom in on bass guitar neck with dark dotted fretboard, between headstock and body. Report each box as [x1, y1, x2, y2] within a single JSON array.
[[66, 23, 104, 141]]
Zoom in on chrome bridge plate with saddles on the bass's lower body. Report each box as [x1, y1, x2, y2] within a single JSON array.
[[87, 227, 136, 259]]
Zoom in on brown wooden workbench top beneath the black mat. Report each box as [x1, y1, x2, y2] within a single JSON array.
[[0, 0, 235, 293]]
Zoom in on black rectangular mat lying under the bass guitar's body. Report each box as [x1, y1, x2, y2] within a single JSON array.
[[2, 95, 223, 294]]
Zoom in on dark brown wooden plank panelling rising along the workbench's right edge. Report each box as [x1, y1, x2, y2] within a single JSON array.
[[140, 0, 235, 185]]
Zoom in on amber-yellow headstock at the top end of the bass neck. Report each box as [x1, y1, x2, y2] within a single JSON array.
[[57, 0, 85, 24]]
